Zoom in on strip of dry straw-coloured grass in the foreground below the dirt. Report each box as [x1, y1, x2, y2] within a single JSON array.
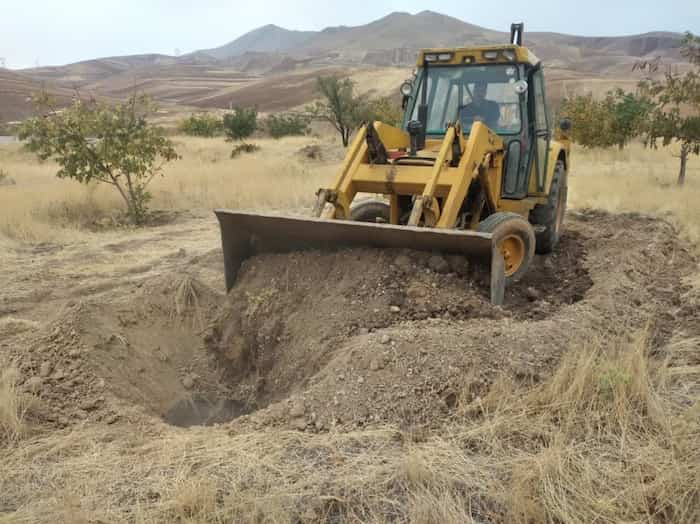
[[0, 335, 700, 524]]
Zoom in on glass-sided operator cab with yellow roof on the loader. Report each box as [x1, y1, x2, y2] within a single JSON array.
[[401, 24, 551, 199]]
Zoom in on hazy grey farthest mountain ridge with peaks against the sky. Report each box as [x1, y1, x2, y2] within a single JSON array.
[[197, 11, 680, 74]]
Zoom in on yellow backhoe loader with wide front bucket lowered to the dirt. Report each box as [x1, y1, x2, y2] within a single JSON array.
[[216, 24, 570, 304]]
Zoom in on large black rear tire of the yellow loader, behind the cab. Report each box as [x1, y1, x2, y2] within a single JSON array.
[[530, 160, 568, 255]]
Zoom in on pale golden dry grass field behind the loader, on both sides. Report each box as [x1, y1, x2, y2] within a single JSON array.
[[0, 137, 700, 249]]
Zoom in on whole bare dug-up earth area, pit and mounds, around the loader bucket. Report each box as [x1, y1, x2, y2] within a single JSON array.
[[0, 212, 698, 432]]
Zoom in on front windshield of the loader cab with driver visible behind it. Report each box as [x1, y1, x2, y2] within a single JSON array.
[[411, 64, 521, 135]]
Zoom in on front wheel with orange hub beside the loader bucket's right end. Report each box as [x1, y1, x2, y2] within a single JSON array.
[[477, 213, 536, 285]]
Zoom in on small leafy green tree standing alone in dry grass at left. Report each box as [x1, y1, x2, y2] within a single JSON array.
[[19, 95, 179, 224]]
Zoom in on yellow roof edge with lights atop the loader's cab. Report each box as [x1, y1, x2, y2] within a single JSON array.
[[417, 44, 540, 67]]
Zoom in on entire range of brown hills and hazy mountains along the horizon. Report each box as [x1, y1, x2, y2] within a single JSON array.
[[0, 11, 683, 121]]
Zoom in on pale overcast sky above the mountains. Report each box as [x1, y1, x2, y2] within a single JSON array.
[[0, 0, 700, 69]]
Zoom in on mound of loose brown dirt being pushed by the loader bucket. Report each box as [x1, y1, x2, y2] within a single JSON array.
[[207, 213, 692, 431]]
